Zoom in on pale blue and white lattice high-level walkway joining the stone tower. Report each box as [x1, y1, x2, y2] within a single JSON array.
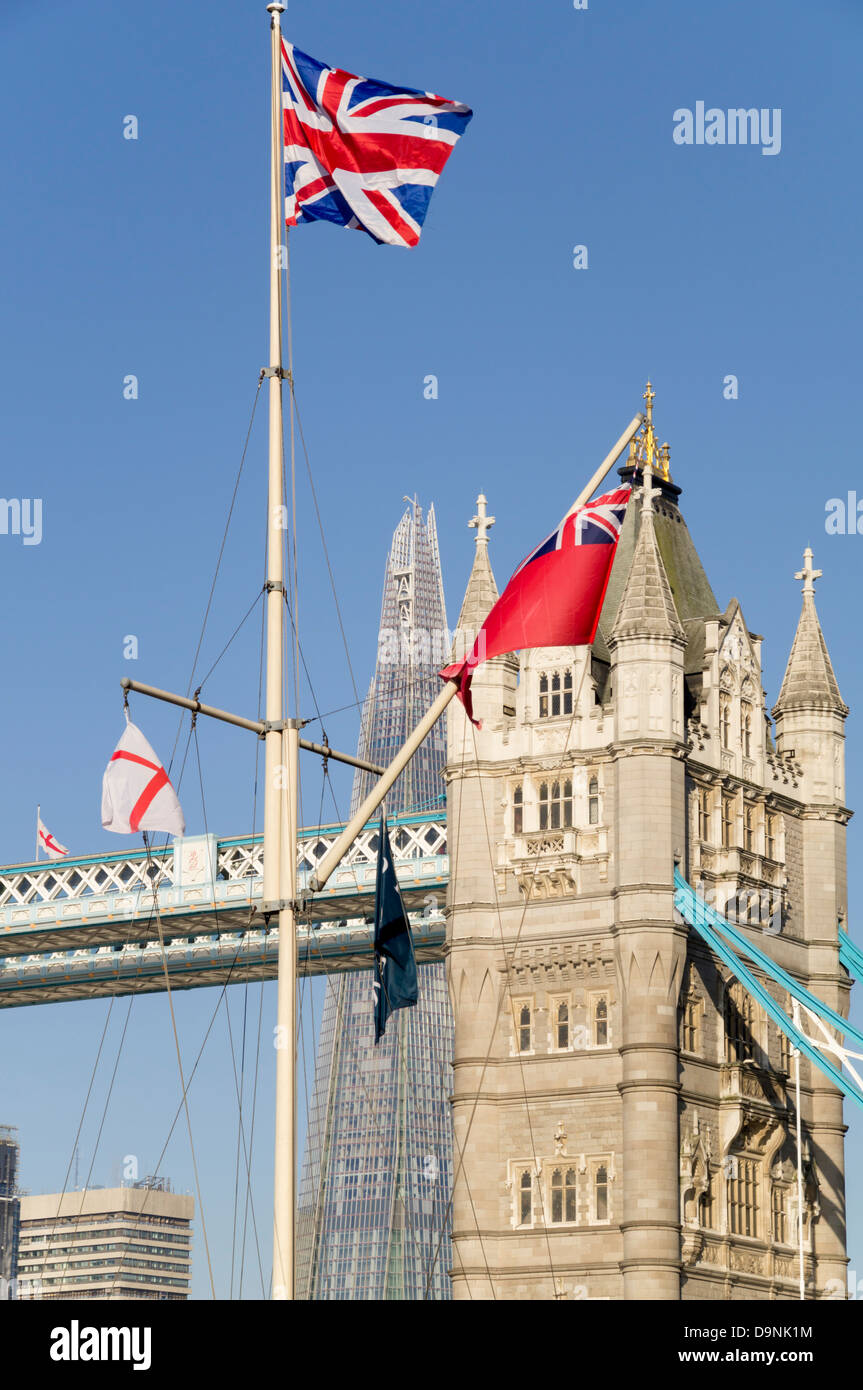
[[0, 816, 449, 1008]]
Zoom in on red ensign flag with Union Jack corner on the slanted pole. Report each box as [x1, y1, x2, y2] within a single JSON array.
[[439, 487, 632, 724]]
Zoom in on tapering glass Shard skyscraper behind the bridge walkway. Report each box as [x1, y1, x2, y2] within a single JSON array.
[[297, 499, 453, 1300]]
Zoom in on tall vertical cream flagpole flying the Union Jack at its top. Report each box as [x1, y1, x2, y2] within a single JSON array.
[[263, 3, 297, 1300]]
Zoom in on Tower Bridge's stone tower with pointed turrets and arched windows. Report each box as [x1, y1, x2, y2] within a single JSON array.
[[446, 388, 849, 1300]]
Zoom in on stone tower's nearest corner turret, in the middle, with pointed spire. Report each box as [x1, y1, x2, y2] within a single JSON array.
[[609, 386, 687, 1300]]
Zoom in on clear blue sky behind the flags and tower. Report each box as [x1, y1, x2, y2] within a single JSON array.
[[0, 0, 863, 1297]]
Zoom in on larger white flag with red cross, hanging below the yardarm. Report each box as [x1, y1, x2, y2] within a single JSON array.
[[101, 720, 186, 835]]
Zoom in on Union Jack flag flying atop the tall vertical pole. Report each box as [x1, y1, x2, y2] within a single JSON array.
[[282, 40, 472, 246]]
